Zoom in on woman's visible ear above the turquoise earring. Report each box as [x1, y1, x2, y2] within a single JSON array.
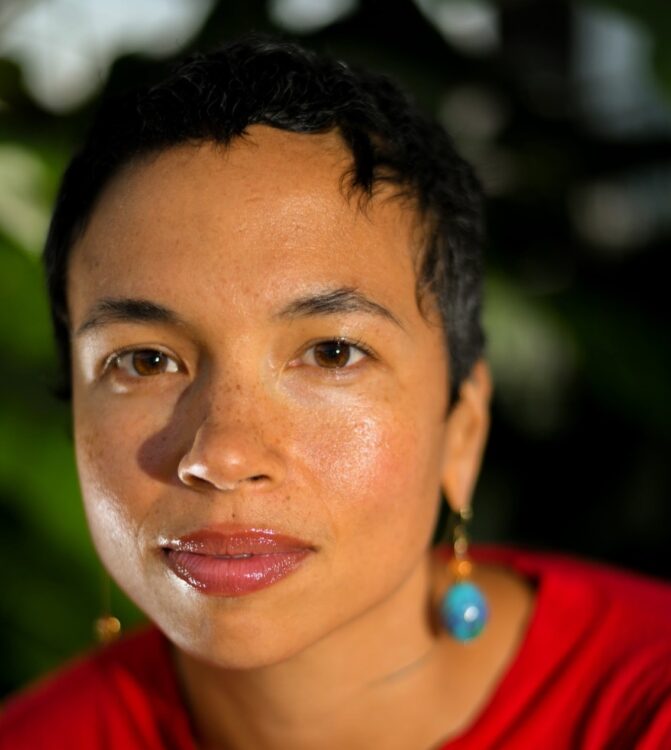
[[441, 359, 492, 511]]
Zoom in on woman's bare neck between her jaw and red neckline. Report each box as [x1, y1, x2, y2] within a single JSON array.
[[176, 560, 454, 750]]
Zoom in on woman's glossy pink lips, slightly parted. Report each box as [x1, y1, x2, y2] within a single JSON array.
[[162, 528, 314, 596]]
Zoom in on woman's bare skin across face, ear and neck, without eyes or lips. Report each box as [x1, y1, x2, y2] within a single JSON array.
[[68, 126, 532, 749]]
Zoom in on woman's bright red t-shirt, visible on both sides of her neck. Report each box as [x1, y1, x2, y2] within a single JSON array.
[[0, 546, 671, 750]]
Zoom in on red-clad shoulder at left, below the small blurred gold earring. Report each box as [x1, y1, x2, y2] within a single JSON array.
[[0, 628, 194, 750]]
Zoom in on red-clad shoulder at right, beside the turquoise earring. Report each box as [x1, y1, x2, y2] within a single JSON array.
[[460, 546, 671, 750]]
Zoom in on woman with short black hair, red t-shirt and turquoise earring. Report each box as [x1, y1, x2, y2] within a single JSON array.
[[0, 38, 671, 750]]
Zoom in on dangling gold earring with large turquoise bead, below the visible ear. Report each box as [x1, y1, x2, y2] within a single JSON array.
[[440, 508, 489, 641]]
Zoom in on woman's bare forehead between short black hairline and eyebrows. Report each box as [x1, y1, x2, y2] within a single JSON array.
[[68, 126, 434, 328]]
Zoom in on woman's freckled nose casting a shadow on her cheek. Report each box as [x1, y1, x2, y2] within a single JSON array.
[[177, 388, 286, 492]]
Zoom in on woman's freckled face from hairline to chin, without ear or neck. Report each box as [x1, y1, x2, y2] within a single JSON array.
[[68, 127, 478, 666]]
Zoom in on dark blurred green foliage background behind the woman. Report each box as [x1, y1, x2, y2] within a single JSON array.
[[0, 0, 671, 695]]
